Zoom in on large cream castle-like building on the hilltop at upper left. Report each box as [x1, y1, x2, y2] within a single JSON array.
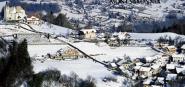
[[4, 5, 26, 21]]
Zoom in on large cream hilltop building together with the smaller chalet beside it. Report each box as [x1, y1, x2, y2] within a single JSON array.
[[4, 4, 41, 25]]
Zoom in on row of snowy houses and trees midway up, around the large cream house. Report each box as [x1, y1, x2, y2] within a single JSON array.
[[70, 28, 150, 47]]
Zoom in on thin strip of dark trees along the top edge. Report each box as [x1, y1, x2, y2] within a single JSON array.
[[110, 0, 161, 4]]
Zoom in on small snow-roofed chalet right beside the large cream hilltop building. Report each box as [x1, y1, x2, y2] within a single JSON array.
[[27, 13, 41, 25]]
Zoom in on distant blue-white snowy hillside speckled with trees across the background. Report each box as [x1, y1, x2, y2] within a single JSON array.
[[0, 0, 185, 32]]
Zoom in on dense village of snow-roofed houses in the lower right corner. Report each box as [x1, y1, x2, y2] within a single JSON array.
[[109, 45, 185, 87]]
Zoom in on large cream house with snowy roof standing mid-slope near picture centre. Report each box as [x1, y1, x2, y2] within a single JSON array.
[[80, 29, 96, 40]]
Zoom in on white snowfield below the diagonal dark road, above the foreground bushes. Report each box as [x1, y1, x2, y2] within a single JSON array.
[[33, 59, 125, 87]]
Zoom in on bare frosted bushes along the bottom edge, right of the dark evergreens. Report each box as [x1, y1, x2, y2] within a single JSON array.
[[28, 69, 96, 87]]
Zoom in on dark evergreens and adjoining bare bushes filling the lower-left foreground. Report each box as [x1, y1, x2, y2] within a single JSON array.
[[0, 40, 96, 87]]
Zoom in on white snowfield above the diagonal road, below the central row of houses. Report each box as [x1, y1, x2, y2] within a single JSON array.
[[74, 42, 157, 61]]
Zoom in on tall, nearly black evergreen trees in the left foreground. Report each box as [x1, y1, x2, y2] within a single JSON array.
[[0, 40, 33, 87]]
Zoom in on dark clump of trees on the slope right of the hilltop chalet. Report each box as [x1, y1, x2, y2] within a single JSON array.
[[42, 11, 74, 29]]
